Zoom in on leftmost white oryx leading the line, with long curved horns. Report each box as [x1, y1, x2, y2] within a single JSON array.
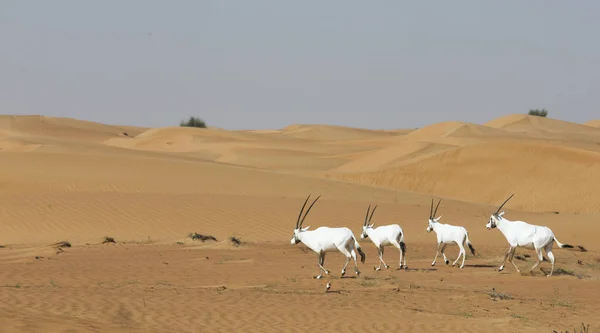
[[291, 194, 366, 279]]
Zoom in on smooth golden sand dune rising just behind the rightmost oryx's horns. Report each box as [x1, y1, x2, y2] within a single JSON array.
[[330, 143, 600, 212]]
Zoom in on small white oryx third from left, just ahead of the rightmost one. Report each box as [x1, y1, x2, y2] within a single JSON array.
[[427, 199, 475, 268]]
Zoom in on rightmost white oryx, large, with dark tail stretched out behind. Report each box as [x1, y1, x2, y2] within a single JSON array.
[[485, 193, 573, 276]]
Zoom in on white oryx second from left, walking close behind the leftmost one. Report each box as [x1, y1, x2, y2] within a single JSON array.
[[360, 205, 407, 271]]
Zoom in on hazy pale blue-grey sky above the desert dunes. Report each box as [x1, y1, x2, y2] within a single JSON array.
[[0, 0, 600, 129]]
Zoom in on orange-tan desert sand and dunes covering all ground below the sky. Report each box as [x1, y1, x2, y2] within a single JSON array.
[[0, 115, 600, 333]]
